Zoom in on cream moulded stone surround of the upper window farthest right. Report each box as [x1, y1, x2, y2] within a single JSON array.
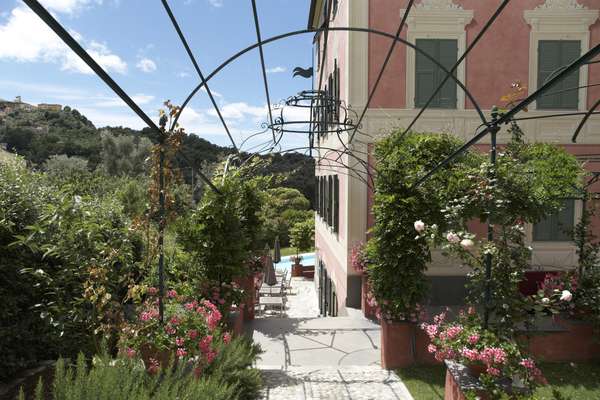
[[523, 0, 599, 111]]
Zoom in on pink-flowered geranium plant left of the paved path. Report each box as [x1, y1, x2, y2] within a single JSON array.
[[120, 287, 231, 372]]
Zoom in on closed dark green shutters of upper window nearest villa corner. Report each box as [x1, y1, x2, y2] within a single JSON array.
[[415, 39, 458, 108]]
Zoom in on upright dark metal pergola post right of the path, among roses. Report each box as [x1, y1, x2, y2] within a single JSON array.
[[483, 107, 500, 329]]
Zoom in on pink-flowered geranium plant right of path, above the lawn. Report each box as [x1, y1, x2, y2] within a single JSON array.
[[421, 307, 547, 393]]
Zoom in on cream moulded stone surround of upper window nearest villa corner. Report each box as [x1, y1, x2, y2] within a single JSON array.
[[400, 0, 473, 110]]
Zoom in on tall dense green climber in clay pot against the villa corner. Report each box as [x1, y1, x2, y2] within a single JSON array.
[[367, 131, 481, 321]]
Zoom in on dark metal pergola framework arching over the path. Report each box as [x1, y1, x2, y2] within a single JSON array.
[[23, 0, 600, 326]]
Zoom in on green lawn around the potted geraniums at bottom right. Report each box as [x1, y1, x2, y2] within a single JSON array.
[[397, 363, 600, 400]]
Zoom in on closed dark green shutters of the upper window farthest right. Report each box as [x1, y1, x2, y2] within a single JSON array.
[[537, 40, 581, 110]]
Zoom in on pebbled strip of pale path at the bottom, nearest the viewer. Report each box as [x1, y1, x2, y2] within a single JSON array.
[[262, 366, 413, 400]]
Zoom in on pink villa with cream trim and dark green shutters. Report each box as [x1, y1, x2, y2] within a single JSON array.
[[308, 0, 600, 316]]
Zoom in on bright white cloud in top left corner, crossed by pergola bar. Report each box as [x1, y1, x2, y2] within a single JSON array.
[[0, 5, 127, 74]]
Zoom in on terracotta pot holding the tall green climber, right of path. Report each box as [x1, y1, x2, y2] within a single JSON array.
[[381, 320, 416, 369]]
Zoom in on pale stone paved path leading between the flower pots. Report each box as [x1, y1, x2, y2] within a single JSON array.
[[246, 278, 412, 400]]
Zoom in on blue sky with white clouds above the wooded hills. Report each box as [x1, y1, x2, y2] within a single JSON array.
[[0, 0, 312, 147]]
